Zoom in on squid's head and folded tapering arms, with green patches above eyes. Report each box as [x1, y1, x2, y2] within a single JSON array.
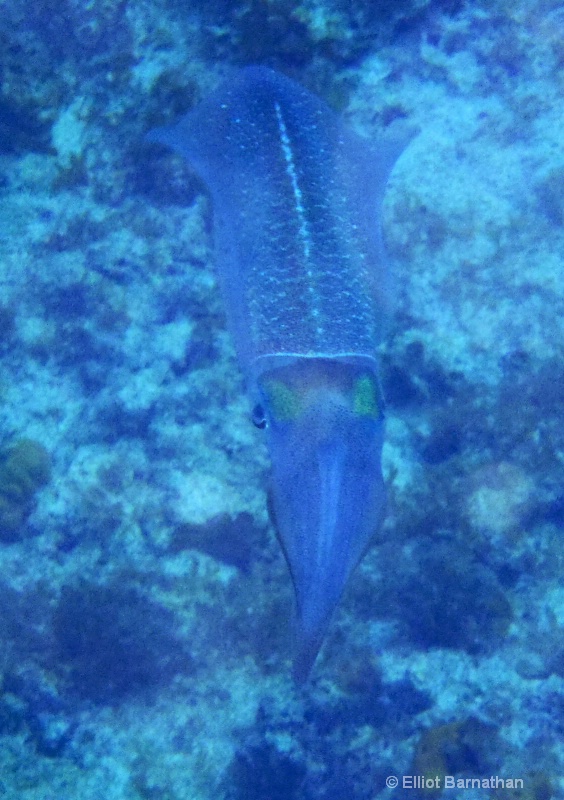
[[259, 358, 385, 679]]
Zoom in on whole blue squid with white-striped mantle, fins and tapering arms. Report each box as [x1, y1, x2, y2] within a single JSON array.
[[149, 67, 405, 679]]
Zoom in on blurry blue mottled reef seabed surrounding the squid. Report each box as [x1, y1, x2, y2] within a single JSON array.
[[0, 0, 564, 800]]
